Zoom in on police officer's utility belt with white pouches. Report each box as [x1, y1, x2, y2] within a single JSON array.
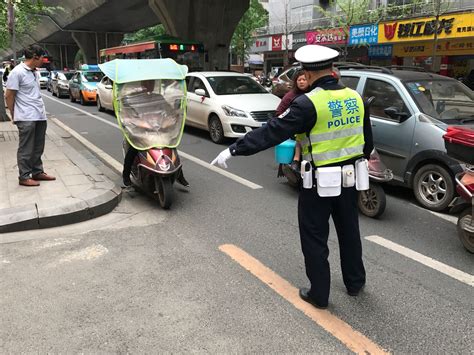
[[301, 158, 369, 197]]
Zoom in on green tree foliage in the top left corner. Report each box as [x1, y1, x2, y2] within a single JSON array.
[[0, 0, 60, 49]]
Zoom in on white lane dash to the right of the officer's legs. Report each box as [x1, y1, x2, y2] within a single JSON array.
[[365, 235, 474, 287]]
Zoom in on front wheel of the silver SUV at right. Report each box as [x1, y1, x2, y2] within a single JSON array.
[[413, 164, 454, 212]]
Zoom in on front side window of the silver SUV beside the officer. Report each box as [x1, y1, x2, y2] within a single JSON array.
[[363, 79, 410, 120]]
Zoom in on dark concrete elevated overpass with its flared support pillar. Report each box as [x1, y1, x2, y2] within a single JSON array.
[[0, 0, 249, 69]]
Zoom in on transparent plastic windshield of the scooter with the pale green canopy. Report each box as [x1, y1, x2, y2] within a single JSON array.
[[115, 80, 185, 149]]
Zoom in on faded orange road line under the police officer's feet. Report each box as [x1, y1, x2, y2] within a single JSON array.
[[219, 244, 388, 354]]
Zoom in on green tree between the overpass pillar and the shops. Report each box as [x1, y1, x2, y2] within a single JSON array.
[[231, 0, 268, 64]]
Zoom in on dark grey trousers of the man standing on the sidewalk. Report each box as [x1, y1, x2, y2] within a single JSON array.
[[15, 120, 47, 180]]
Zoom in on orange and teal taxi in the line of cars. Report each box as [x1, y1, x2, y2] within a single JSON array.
[[69, 66, 104, 105]]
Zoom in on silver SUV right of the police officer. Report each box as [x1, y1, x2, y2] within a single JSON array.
[[339, 66, 474, 211]]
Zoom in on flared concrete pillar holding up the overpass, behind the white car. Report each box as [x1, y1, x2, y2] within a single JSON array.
[[148, 0, 249, 70]]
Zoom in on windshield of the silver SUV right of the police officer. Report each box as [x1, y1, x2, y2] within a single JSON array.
[[405, 78, 474, 124]]
